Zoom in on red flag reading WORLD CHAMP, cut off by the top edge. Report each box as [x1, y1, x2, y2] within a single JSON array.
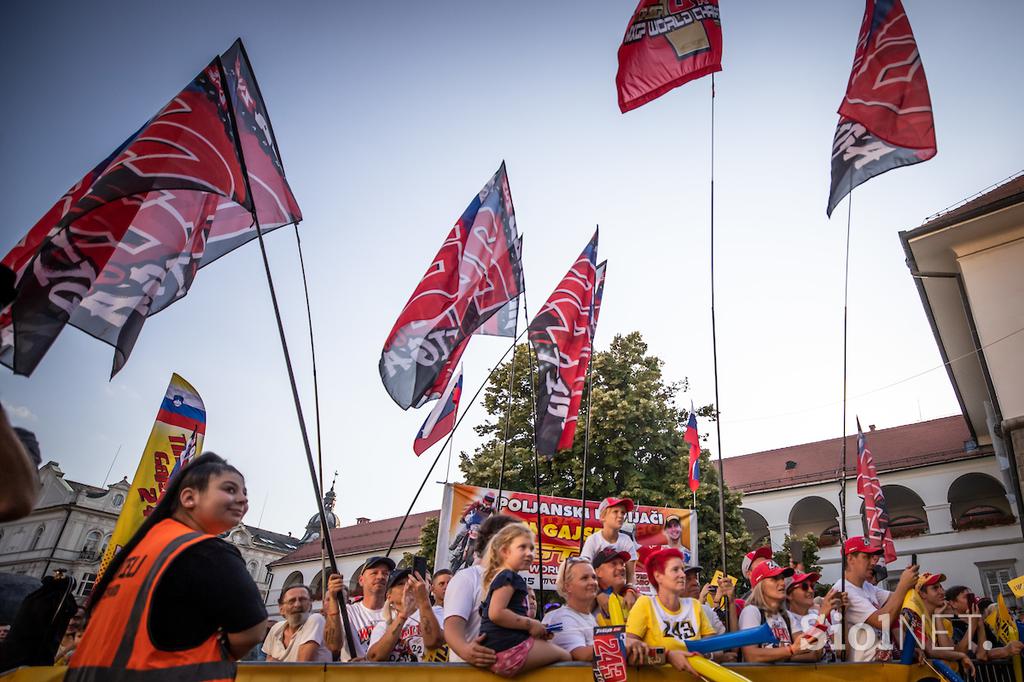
[[615, 0, 722, 114]]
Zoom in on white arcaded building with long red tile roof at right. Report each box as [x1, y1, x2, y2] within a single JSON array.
[[724, 416, 1024, 605]]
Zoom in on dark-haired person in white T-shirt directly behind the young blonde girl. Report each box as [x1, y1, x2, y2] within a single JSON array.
[[441, 514, 518, 668]]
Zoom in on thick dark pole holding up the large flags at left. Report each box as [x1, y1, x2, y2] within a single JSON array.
[[216, 55, 355, 657]]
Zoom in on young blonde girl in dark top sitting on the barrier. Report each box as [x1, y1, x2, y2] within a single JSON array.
[[480, 523, 571, 677]]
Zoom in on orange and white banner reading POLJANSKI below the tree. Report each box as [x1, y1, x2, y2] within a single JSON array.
[[434, 483, 697, 593]]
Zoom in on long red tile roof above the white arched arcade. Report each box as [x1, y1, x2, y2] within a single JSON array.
[[722, 415, 978, 493]]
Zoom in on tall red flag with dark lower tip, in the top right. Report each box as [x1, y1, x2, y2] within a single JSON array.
[[825, 0, 937, 216]]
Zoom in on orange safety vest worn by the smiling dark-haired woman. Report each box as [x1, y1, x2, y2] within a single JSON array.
[[65, 518, 236, 682]]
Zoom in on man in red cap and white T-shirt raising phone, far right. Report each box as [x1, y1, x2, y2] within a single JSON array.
[[843, 536, 918, 663]]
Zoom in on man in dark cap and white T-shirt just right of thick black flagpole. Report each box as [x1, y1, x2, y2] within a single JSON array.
[[324, 556, 394, 660]]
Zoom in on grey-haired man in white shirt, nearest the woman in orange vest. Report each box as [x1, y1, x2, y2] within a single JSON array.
[[263, 585, 331, 663]]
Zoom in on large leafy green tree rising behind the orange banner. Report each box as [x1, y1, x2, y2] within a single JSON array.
[[459, 332, 750, 574]]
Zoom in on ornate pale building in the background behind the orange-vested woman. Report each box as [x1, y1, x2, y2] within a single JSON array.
[[0, 462, 299, 601]]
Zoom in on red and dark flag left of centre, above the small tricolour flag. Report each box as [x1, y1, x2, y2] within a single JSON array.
[[379, 163, 523, 410]]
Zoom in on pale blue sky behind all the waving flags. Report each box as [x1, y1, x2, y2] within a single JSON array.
[[0, 0, 1024, 534]]
